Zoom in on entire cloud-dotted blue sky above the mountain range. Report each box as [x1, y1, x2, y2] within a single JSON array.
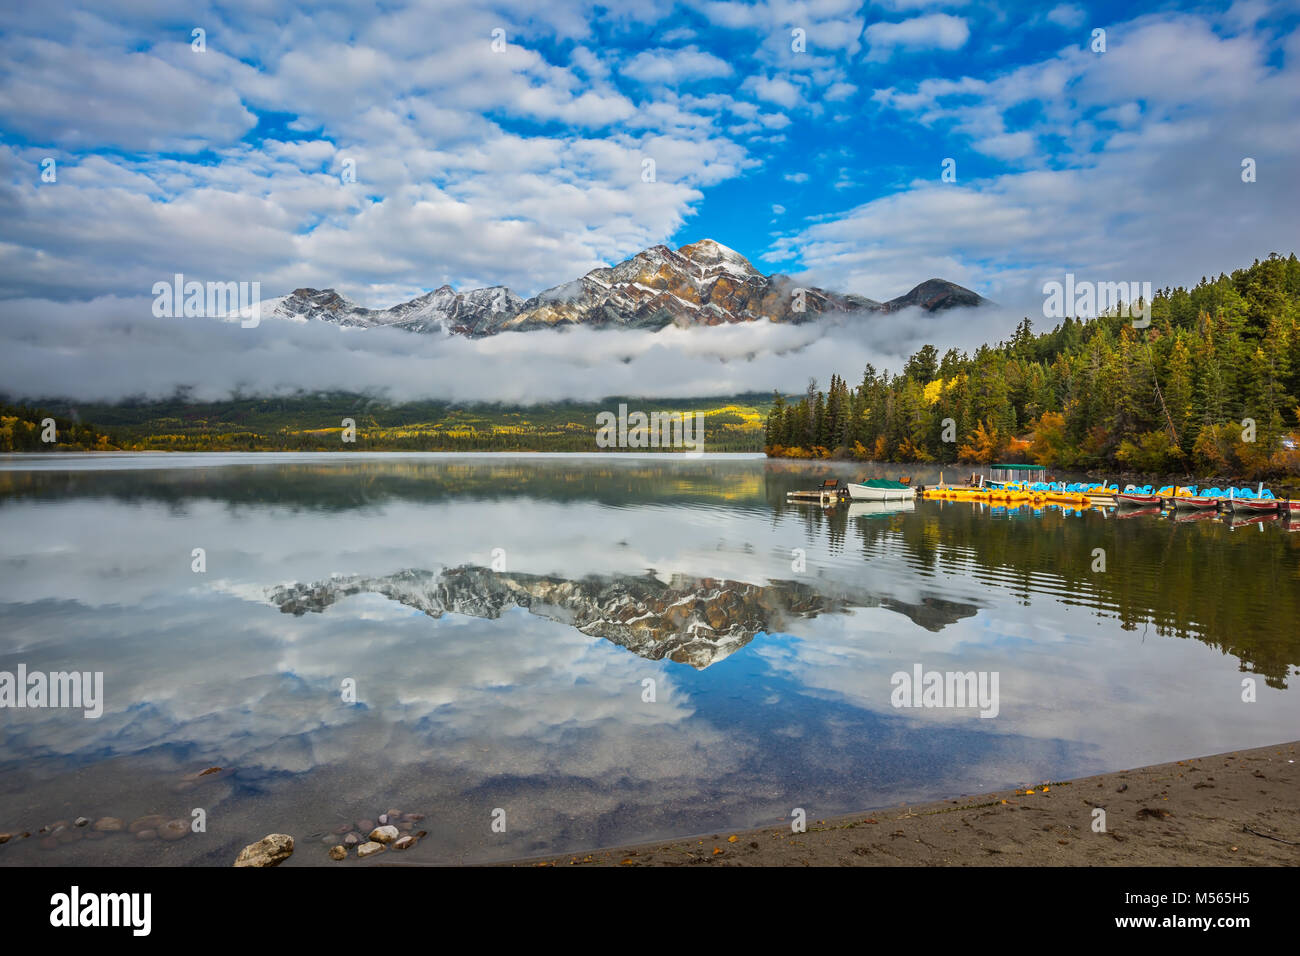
[[0, 0, 1300, 306]]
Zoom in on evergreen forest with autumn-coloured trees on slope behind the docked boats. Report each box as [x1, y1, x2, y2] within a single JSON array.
[[763, 254, 1300, 479]]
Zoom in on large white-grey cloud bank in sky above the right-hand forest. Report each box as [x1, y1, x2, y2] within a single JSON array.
[[768, 9, 1300, 303]]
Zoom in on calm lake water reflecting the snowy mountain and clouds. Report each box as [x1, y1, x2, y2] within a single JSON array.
[[0, 454, 1300, 866]]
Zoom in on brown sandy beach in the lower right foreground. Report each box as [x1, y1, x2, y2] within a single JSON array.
[[494, 740, 1300, 866]]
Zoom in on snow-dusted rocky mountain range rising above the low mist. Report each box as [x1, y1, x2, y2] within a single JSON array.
[[268, 239, 984, 337]]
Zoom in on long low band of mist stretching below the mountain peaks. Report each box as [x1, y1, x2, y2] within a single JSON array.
[[0, 295, 1019, 405]]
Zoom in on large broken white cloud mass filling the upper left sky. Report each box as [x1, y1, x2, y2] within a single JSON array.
[[0, 0, 754, 306]]
